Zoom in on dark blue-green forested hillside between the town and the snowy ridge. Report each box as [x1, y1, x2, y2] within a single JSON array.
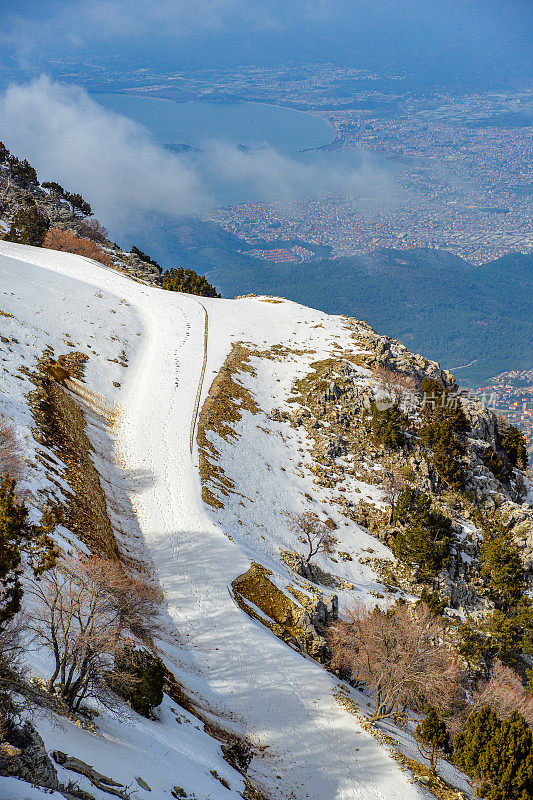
[[127, 215, 533, 386]]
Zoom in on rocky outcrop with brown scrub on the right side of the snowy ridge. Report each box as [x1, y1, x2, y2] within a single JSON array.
[[280, 328, 533, 614]]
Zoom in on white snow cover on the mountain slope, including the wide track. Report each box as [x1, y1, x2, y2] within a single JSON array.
[[0, 242, 472, 800]]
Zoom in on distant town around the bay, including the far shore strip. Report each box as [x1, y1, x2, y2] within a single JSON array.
[[36, 59, 533, 264]]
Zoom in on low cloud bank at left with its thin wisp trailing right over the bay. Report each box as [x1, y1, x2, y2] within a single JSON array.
[[0, 76, 395, 232]]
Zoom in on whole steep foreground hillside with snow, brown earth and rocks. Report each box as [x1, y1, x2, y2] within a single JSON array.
[[0, 242, 533, 800]]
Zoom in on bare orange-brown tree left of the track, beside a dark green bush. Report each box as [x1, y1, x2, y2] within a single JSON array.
[[28, 557, 159, 710]]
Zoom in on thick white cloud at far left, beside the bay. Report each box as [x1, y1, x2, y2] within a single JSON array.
[[0, 77, 210, 226]]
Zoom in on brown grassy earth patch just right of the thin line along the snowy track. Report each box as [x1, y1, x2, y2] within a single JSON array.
[[196, 342, 259, 508]]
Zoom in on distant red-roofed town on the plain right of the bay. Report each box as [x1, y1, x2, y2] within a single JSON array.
[[196, 70, 533, 264]]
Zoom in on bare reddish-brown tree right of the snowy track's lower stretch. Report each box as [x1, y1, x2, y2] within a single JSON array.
[[328, 603, 464, 721]]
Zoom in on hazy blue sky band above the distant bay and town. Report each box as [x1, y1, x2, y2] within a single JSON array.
[[0, 0, 533, 87]]
